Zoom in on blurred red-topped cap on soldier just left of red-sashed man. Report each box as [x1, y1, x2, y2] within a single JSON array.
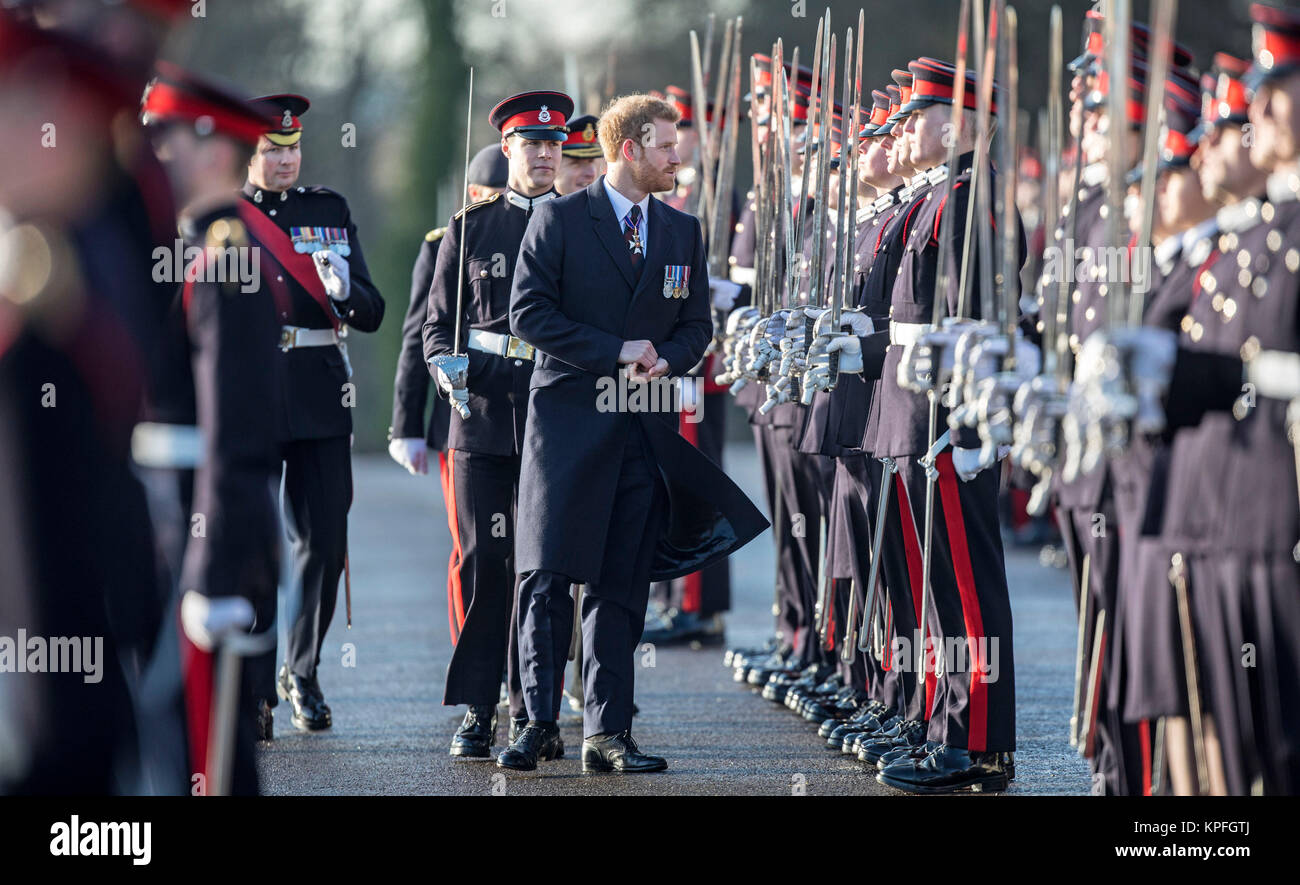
[[140, 61, 280, 144]]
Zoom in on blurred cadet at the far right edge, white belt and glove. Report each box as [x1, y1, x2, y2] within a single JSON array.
[[1102, 4, 1300, 795]]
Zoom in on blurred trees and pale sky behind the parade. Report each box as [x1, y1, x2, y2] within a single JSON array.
[[165, 0, 1251, 451]]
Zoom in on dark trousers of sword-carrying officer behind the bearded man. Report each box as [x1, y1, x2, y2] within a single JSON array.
[[442, 450, 523, 715]]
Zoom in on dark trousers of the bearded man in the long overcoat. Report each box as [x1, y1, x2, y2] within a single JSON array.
[[519, 429, 667, 737]]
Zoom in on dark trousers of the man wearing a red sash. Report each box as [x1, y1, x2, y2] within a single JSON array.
[[282, 437, 352, 677]]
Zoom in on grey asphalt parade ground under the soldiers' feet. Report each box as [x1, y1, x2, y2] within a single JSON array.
[[259, 434, 1089, 795]]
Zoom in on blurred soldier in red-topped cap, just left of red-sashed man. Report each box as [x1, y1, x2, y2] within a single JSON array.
[[133, 62, 290, 794]]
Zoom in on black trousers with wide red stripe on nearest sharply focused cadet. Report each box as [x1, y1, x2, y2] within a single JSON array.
[[885, 451, 1015, 752]]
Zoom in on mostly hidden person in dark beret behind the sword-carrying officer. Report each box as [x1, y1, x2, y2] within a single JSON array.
[[389, 144, 507, 645]]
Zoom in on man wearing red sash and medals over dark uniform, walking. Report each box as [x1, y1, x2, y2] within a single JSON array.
[[243, 95, 384, 732]]
